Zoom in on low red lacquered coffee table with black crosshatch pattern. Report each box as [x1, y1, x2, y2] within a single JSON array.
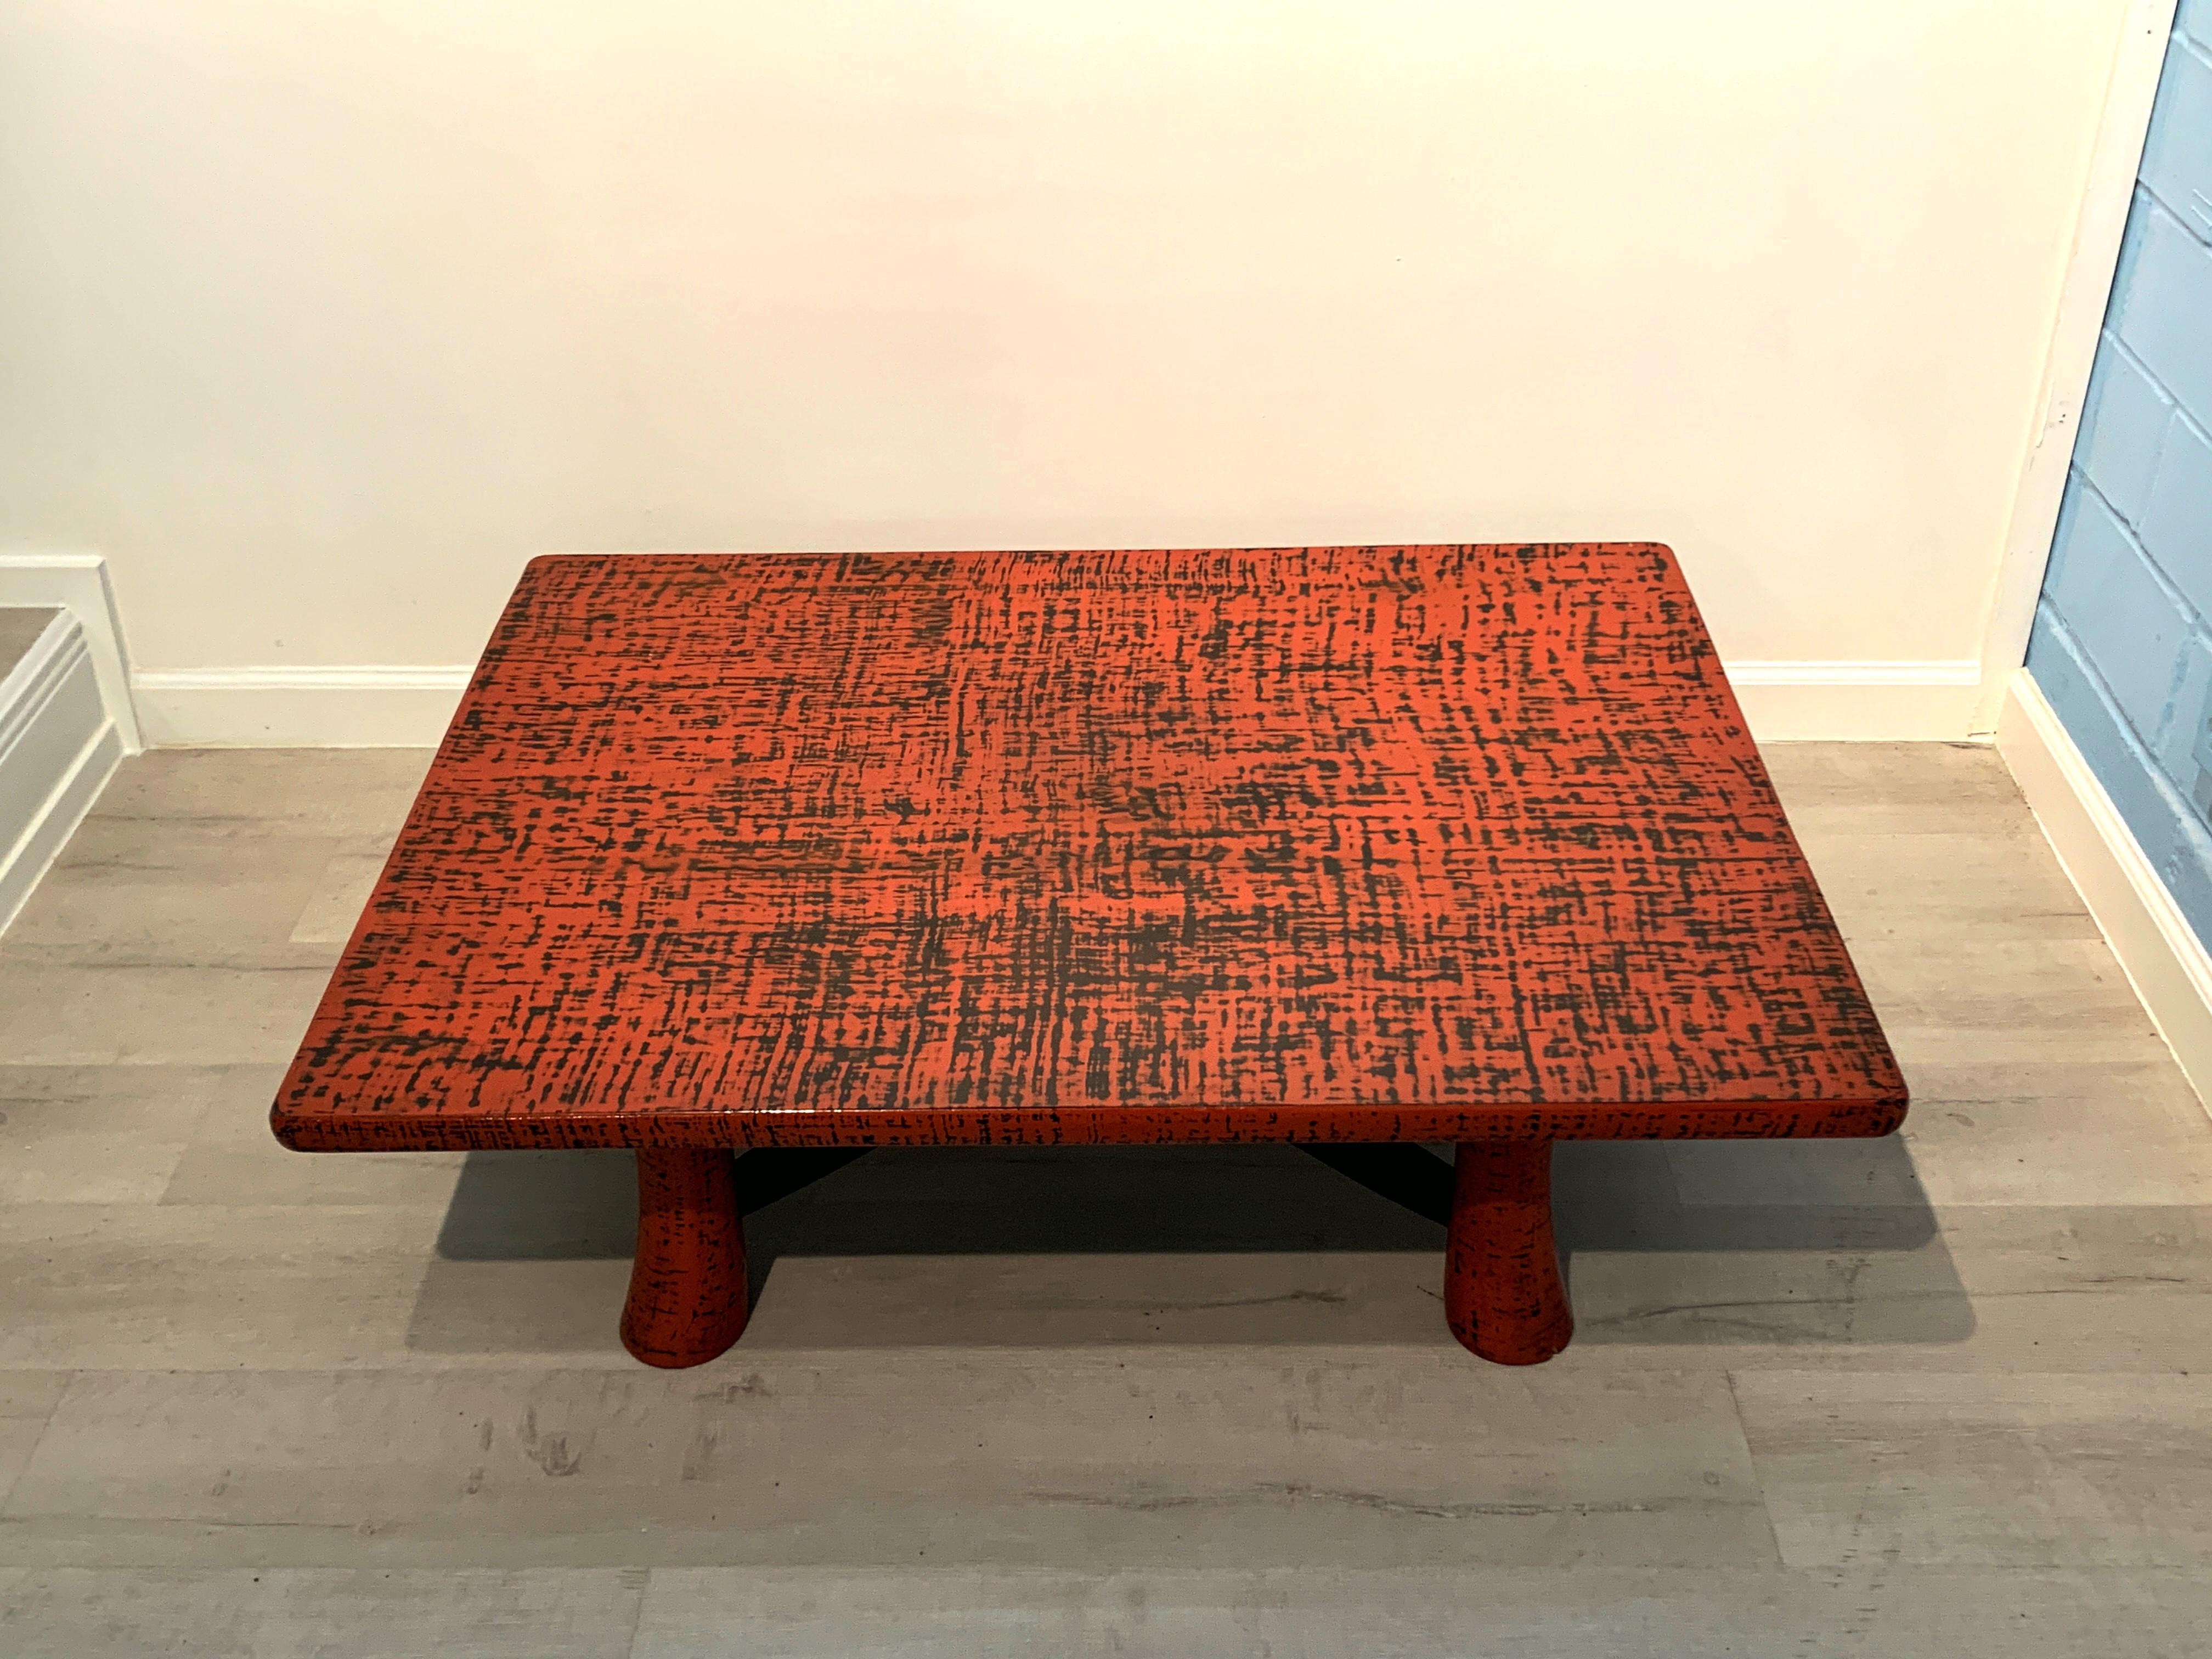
[[272, 544, 1905, 1365]]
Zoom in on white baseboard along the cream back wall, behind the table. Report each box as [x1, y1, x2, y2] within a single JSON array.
[[133, 662, 1978, 748]]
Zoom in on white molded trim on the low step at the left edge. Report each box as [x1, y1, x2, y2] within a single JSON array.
[[0, 611, 124, 929]]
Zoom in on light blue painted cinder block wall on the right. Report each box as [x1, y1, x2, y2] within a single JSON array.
[[2028, 0, 2212, 940]]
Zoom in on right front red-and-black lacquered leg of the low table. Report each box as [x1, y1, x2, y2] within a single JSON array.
[[1444, 1142, 1575, 1365]]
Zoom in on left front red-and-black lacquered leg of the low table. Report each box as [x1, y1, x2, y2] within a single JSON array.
[[622, 1146, 746, 1367]]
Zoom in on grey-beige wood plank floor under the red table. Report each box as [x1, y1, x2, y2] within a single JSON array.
[[0, 746, 2212, 1659]]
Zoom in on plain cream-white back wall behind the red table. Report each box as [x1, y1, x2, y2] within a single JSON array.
[[0, 0, 2126, 738]]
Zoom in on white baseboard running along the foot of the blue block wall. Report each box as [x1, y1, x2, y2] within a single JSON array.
[[1997, 668, 2212, 1106]]
